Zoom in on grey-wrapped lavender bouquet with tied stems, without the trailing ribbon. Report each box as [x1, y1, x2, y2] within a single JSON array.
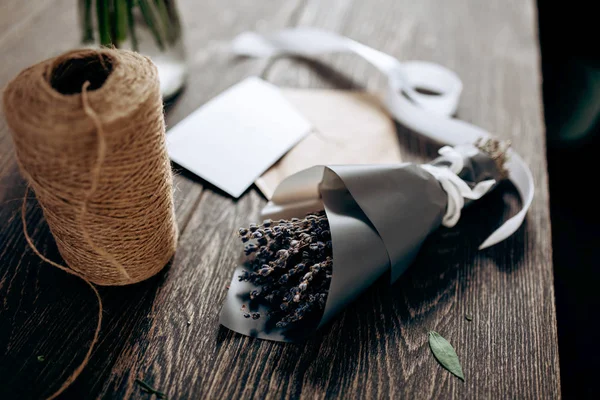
[[221, 139, 508, 341]]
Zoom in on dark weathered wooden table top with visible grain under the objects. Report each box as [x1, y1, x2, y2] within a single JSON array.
[[0, 0, 560, 399]]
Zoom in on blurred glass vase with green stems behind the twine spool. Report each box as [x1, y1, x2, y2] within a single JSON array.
[[78, 0, 187, 101]]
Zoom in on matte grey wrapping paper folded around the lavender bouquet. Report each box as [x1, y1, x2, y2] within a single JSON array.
[[220, 146, 503, 341]]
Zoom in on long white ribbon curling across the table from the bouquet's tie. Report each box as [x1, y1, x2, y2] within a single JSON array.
[[232, 28, 534, 249]]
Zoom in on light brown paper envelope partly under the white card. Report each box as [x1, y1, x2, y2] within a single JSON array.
[[255, 89, 401, 199]]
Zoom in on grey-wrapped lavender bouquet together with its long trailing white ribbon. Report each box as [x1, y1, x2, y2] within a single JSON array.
[[221, 27, 535, 341]]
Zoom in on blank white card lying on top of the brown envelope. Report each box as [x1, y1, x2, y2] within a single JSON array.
[[167, 77, 311, 198]]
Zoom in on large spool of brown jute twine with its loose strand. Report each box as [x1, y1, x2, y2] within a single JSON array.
[[4, 49, 177, 398]]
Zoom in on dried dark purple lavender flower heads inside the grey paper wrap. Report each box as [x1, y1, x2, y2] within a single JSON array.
[[238, 211, 333, 328]]
